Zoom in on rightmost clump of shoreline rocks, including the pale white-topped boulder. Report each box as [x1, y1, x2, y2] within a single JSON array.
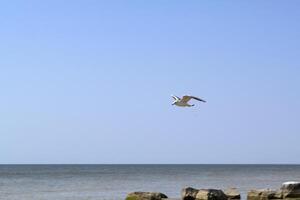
[[247, 182, 300, 200]]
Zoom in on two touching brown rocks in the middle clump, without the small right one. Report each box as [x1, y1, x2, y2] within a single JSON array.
[[181, 187, 227, 200]]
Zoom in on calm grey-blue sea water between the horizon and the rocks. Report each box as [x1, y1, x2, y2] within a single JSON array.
[[0, 165, 300, 200]]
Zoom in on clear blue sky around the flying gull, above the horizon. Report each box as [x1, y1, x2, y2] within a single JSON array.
[[0, 0, 300, 164]]
